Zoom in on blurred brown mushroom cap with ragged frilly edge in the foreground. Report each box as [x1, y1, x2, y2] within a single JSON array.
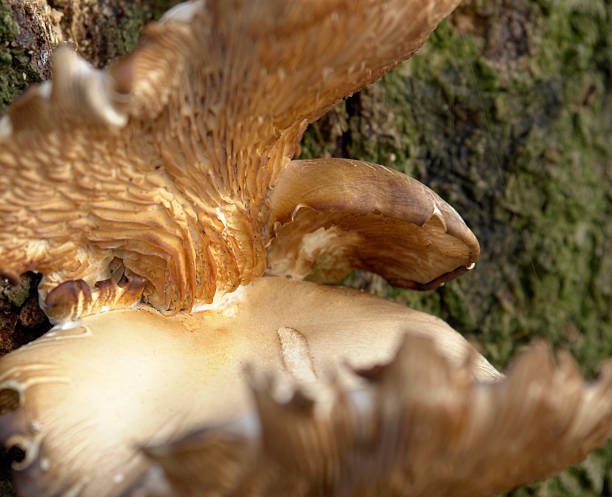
[[129, 335, 612, 497]]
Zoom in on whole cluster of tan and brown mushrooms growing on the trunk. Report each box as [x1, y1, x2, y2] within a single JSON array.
[[0, 0, 612, 497]]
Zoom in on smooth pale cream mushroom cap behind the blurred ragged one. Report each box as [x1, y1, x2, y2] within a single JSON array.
[[0, 278, 500, 497]]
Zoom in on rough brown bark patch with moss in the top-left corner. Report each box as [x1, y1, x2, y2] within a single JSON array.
[[0, 0, 179, 113]]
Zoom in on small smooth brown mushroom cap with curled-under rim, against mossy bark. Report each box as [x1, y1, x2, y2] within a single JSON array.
[[268, 159, 480, 290]]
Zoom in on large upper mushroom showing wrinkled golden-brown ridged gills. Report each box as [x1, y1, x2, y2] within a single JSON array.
[[0, 0, 458, 321]]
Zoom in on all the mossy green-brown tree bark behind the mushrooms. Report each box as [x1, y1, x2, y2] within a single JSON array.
[[0, 0, 612, 496]]
